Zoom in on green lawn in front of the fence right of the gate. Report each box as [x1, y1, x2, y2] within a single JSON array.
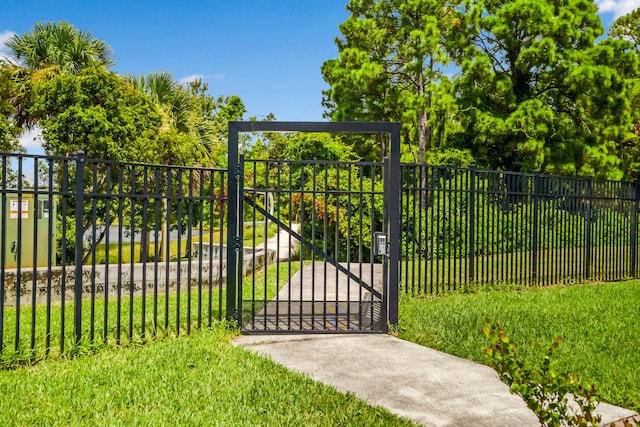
[[398, 280, 640, 411]]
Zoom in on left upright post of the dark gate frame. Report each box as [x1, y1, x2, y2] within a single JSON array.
[[226, 122, 241, 326]]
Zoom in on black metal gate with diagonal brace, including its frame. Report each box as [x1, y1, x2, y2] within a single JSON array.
[[227, 122, 400, 333]]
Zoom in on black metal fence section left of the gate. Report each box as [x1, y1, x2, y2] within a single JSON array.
[[0, 153, 227, 357]]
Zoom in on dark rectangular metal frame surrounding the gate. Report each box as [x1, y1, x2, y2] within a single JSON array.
[[226, 121, 401, 327]]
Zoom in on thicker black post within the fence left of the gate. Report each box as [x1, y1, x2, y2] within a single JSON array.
[[73, 151, 85, 344]]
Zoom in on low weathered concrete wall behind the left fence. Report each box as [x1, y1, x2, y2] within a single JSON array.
[[4, 249, 276, 306]]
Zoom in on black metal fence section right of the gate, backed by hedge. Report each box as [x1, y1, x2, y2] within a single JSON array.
[[400, 164, 639, 293]]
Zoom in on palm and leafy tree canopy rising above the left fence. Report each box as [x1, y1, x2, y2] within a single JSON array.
[[0, 21, 246, 166]]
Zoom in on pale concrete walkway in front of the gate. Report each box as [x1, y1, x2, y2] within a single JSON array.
[[235, 334, 635, 427]]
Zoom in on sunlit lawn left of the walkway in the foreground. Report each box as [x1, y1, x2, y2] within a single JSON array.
[[0, 326, 411, 426]]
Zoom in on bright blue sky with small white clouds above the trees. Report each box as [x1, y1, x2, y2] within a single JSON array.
[[0, 0, 640, 152]]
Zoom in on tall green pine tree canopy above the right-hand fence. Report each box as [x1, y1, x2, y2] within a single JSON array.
[[322, 0, 638, 179]]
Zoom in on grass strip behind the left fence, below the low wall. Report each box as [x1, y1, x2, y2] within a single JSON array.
[[0, 263, 300, 369]]
